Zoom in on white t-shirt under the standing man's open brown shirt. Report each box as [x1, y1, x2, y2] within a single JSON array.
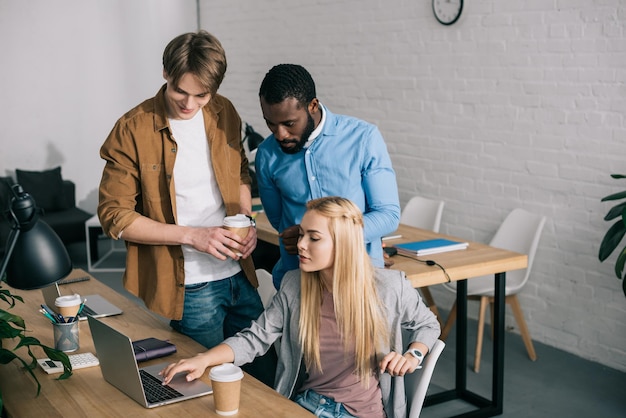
[[169, 111, 241, 285]]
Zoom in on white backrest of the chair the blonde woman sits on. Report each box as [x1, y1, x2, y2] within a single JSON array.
[[404, 340, 446, 418]]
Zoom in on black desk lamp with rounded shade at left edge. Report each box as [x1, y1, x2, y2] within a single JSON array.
[[0, 184, 72, 290]]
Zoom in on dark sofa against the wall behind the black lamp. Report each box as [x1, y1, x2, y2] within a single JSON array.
[[0, 167, 93, 258]]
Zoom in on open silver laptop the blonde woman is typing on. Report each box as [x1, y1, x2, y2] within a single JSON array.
[[88, 316, 213, 408]]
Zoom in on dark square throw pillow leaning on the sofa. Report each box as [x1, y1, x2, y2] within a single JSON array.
[[15, 167, 69, 211]]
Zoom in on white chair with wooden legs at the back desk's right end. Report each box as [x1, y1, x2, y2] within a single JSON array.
[[440, 209, 546, 373]]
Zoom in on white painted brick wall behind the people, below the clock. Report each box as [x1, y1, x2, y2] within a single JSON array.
[[201, 0, 626, 370]]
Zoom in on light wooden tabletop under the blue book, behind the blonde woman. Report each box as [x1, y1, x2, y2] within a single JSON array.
[[251, 212, 528, 287]]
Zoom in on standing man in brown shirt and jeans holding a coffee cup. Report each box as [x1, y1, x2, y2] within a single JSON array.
[[98, 31, 272, 384]]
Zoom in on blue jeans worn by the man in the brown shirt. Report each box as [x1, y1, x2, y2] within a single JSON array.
[[170, 271, 263, 348]]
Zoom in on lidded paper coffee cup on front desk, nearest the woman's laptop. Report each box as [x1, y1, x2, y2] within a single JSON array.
[[209, 363, 243, 416]]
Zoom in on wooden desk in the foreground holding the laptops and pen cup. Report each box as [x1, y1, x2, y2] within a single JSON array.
[[0, 270, 313, 418]]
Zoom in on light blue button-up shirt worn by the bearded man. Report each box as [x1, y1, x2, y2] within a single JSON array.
[[255, 107, 400, 288]]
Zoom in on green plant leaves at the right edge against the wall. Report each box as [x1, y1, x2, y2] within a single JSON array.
[[598, 174, 626, 296]]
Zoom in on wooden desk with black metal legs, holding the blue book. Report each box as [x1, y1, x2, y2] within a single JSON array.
[[256, 212, 528, 417]]
